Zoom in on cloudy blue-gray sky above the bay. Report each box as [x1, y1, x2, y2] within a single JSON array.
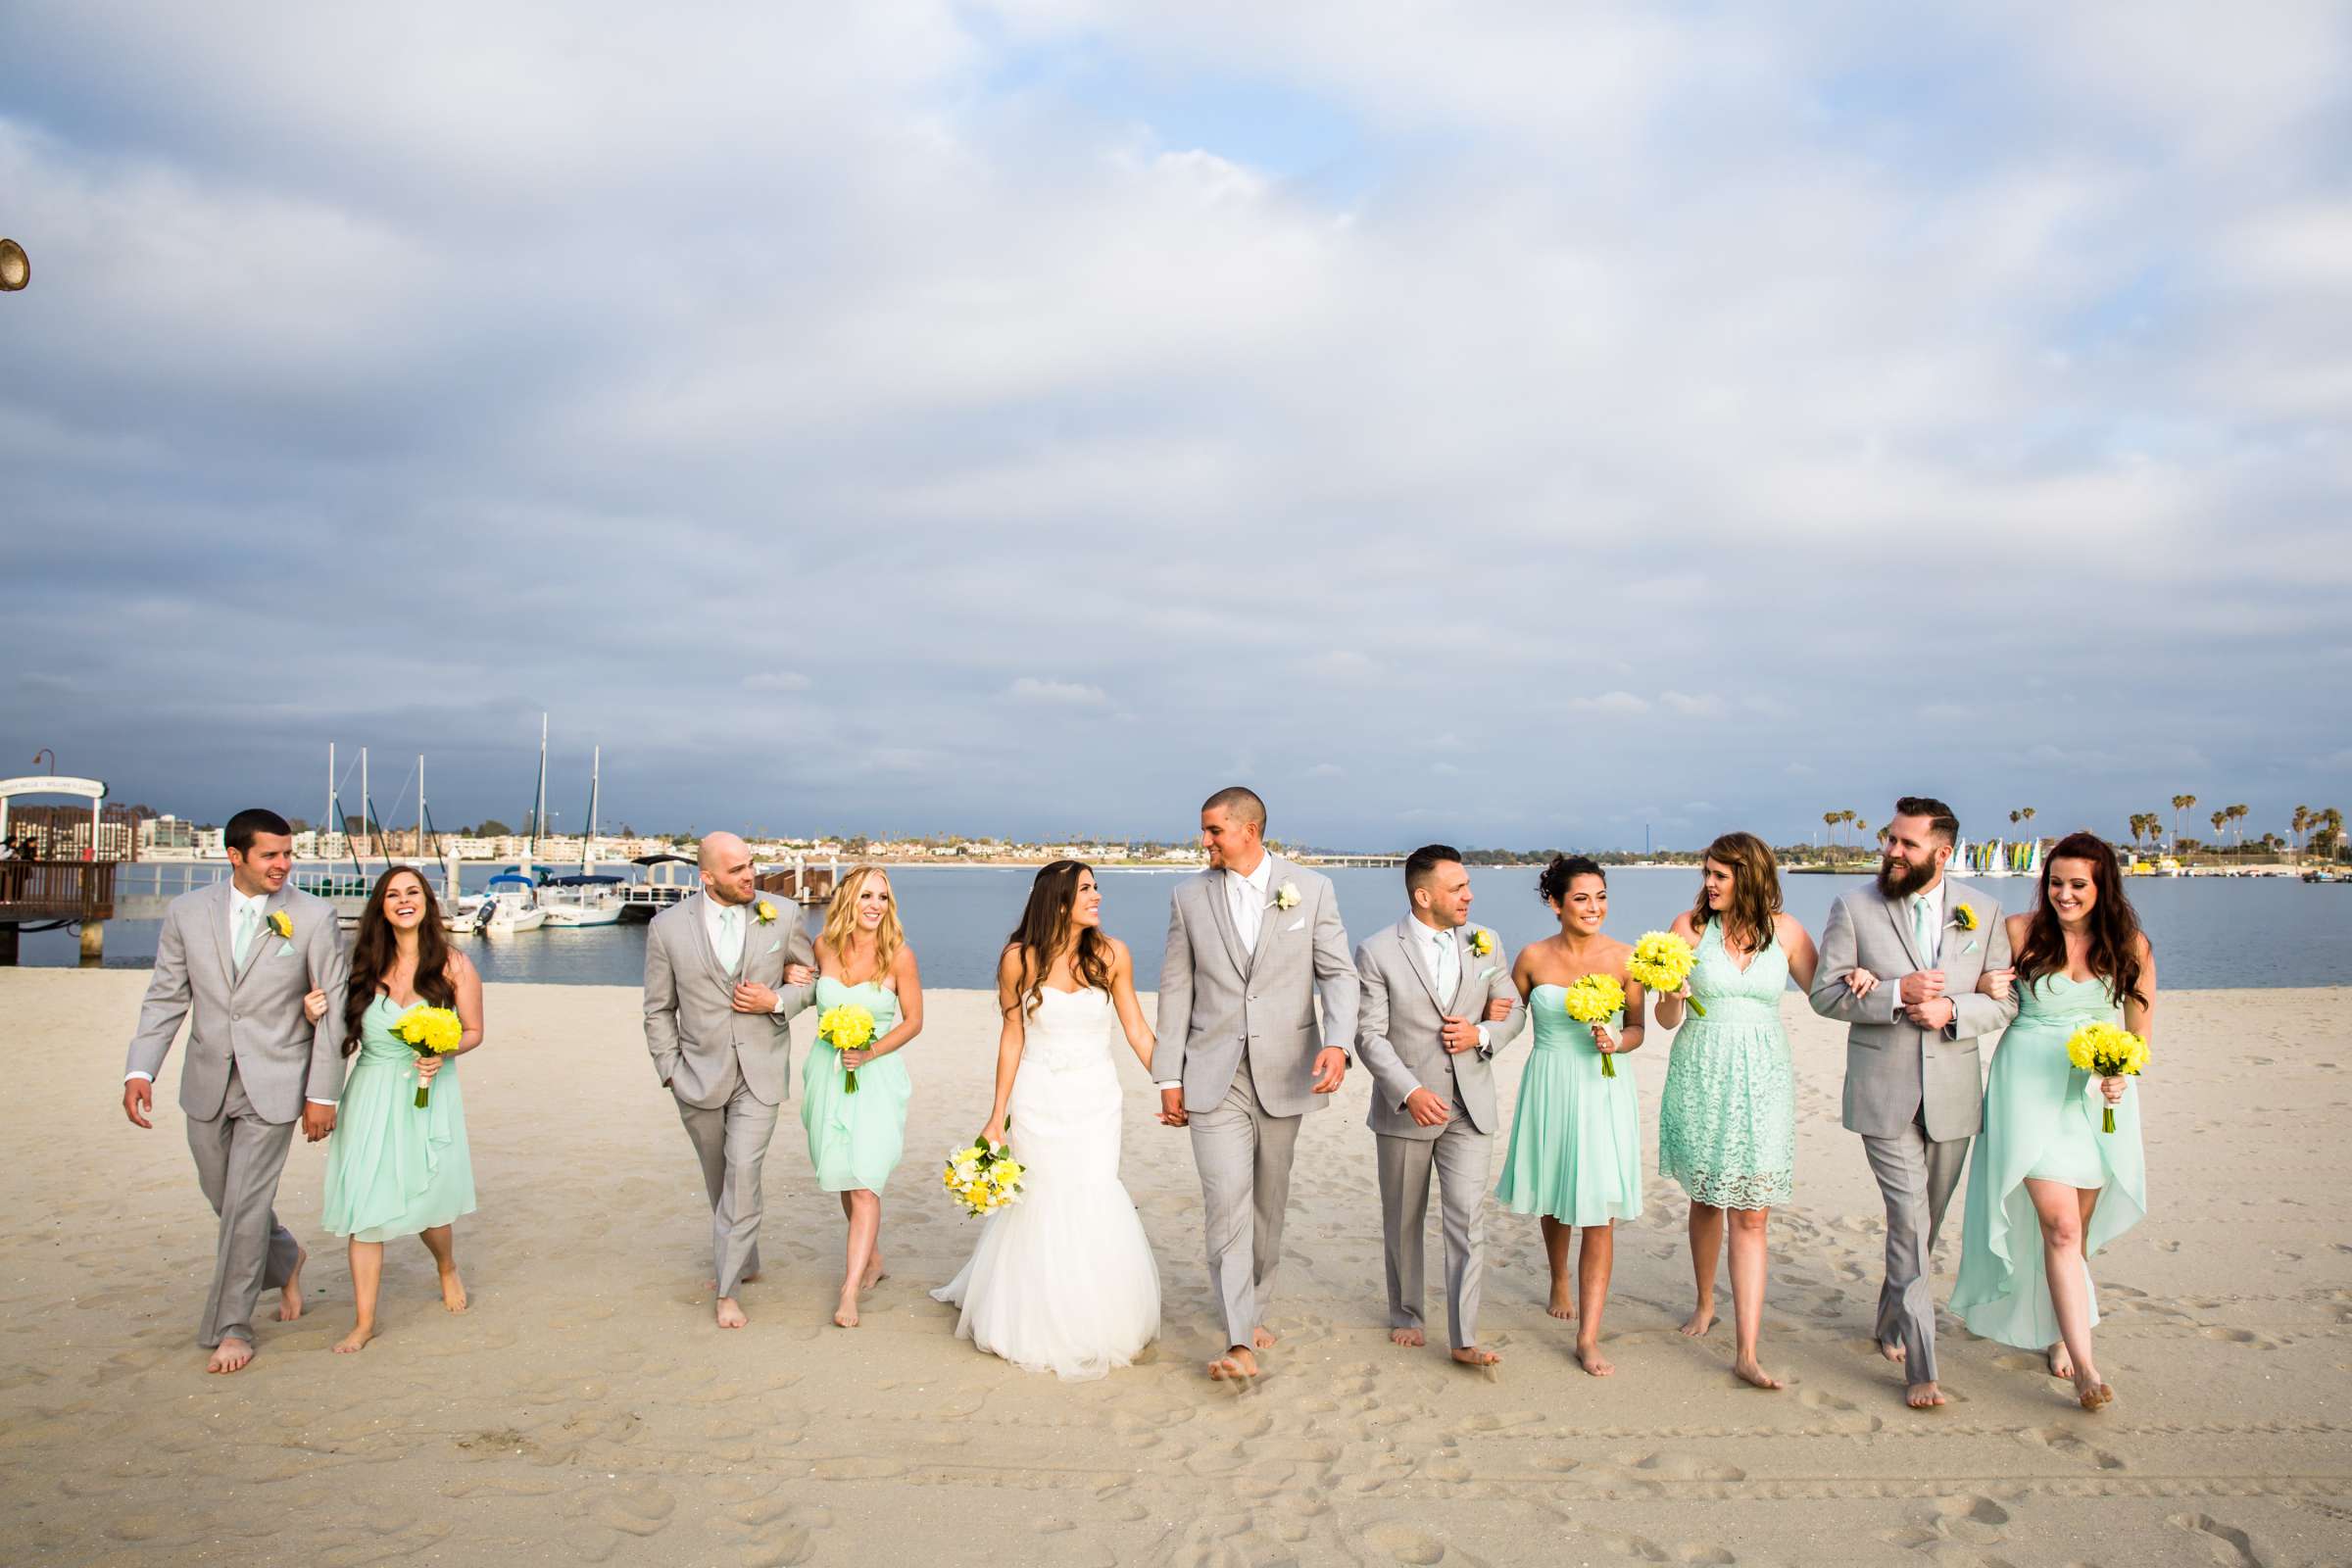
[[0, 0, 2352, 847]]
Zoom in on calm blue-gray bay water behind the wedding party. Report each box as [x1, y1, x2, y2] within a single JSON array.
[[22, 865, 2352, 990]]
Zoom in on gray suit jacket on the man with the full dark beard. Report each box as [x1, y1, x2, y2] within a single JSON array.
[[1811, 879, 2018, 1143]]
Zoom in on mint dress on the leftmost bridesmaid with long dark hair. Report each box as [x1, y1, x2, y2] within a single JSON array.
[[319, 995, 472, 1242]]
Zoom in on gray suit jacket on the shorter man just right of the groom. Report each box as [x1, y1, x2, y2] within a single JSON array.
[[1354, 914, 1527, 1138]]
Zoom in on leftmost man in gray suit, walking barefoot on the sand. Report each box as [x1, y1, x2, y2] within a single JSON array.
[[122, 808, 346, 1373]]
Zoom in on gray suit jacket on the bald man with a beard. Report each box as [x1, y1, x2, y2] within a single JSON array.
[[645, 894, 816, 1109]]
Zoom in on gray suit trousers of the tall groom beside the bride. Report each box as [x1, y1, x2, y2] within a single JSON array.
[[1190, 1051, 1305, 1345]]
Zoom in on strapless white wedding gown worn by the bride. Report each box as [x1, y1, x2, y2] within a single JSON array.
[[931, 987, 1159, 1382]]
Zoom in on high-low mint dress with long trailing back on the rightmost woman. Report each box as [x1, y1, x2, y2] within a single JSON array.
[[1952, 973, 2147, 1349]]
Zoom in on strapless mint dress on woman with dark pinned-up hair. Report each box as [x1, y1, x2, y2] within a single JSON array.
[[1494, 985, 1642, 1225]]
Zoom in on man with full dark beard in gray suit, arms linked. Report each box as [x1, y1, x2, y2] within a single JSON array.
[[1811, 795, 2018, 1410]]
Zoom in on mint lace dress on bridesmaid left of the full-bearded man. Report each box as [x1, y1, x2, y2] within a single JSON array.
[[1658, 919, 1797, 1208]]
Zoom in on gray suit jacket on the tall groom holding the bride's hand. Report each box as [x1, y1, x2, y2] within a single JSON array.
[[1152, 856, 1357, 1116]]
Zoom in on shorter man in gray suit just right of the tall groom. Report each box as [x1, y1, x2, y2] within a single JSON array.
[[1354, 844, 1527, 1366]]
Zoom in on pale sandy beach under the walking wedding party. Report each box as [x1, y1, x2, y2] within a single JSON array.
[[0, 971, 2352, 1568]]
